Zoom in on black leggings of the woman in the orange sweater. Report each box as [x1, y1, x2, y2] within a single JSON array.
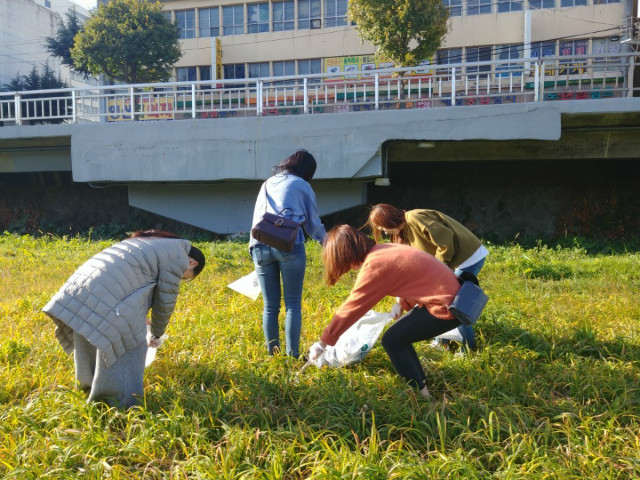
[[381, 307, 460, 390]]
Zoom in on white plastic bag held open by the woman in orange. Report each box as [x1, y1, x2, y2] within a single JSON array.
[[309, 310, 393, 367]]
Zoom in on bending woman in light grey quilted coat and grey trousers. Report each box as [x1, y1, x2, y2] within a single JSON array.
[[43, 230, 205, 408]]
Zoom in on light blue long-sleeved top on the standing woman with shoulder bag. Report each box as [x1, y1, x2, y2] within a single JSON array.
[[249, 173, 327, 248]]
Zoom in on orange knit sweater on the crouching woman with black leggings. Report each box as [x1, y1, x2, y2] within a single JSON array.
[[320, 243, 460, 345]]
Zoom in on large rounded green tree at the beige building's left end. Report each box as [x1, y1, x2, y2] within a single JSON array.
[[71, 0, 181, 83]]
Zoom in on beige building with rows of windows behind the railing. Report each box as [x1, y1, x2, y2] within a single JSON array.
[[162, 0, 637, 81]]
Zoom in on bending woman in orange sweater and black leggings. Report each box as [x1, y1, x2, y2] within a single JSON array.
[[309, 225, 460, 396]]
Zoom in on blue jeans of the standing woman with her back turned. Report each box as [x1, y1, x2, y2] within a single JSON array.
[[251, 243, 307, 358]]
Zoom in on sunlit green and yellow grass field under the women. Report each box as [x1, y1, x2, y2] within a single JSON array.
[[0, 234, 640, 480]]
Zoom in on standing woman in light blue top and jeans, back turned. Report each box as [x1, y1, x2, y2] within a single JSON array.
[[249, 150, 327, 358]]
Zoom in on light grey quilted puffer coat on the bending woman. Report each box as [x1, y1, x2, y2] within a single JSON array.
[[42, 237, 191, 366]]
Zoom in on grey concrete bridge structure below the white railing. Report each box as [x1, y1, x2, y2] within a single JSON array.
[[0, 56, 640, 233]]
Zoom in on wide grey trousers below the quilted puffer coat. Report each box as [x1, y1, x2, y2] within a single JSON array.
[[73, 332, 147, 408]]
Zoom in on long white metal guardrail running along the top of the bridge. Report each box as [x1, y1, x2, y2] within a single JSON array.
[[0, 53, 640, 126]]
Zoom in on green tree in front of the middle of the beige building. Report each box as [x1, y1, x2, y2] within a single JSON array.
[[349, 0, 449, 98]]
